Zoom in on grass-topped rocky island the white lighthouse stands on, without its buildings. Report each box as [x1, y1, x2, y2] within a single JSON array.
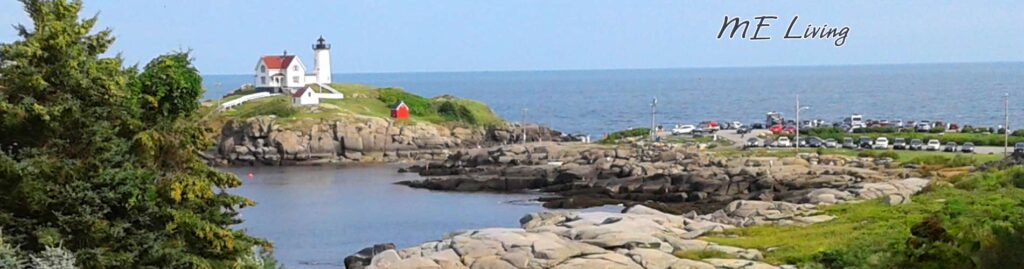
[[201, 84, 574, 166]]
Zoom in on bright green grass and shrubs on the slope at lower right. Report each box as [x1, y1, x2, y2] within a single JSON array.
[[706, 167, 1024, 268]]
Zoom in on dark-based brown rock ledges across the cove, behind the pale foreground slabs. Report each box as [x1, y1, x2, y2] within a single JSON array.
[[398, 142, 925, 214]]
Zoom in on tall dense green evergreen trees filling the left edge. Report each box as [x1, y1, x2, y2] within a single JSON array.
[[0, 0, 270, 268]]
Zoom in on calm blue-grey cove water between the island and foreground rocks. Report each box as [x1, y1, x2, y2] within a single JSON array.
[[224, 166, 621, 268]]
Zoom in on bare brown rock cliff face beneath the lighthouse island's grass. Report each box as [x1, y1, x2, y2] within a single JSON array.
[[214, 116, 572, 165]]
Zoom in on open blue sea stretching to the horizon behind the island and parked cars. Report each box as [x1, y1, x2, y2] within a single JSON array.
[[205, 62, 1024, 136]]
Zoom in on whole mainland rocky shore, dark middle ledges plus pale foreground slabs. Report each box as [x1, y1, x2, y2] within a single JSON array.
[[345, 142, 930, 269]]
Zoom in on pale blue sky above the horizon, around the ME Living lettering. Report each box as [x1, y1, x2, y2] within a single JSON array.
[[0, 0, 1024, 74]]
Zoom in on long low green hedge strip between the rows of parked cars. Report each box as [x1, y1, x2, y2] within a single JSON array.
[[803, 128, 1024, 146]]
